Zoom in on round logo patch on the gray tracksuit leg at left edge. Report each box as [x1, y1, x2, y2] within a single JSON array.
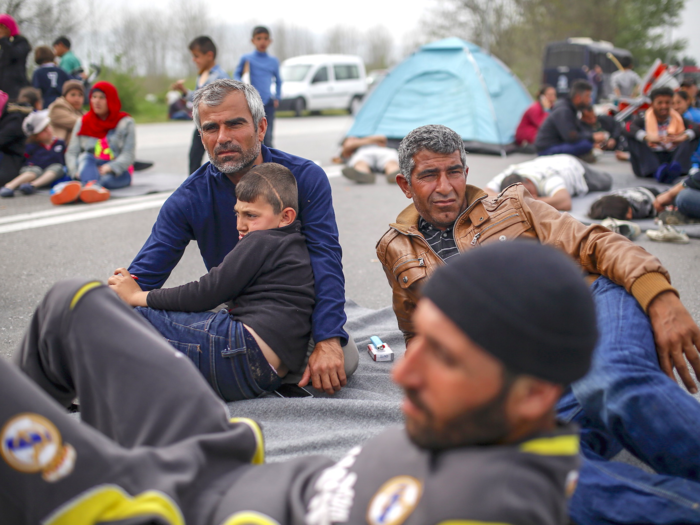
[[0, 413, 76, 482]]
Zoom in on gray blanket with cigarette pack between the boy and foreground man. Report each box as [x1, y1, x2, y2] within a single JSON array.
[[228, 301, 405, 461]]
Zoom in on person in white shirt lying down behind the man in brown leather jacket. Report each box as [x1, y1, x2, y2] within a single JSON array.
[[484, 154, 612, 211]]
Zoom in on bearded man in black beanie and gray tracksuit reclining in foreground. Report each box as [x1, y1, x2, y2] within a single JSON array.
[[0, 243, 596, 525]]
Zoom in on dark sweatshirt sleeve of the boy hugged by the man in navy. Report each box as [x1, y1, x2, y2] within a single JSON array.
[[146, 230, 279, 312]]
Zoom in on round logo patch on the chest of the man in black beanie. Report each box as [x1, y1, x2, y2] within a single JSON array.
[[367, 476, 423, 525]]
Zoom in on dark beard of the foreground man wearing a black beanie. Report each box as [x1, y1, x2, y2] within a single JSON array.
[[405, 377, 513, 450]]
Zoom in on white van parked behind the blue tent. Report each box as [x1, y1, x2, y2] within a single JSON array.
[[278, 55, 367, 116]]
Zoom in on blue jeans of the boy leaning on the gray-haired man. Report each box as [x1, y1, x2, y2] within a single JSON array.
[[136, 307, 281, 401]]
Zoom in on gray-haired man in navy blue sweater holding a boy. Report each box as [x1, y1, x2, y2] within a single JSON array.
[[129, 79, 359, 394]]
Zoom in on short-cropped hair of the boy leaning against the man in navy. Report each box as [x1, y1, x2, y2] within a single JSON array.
[[236, 162, 299, 214]]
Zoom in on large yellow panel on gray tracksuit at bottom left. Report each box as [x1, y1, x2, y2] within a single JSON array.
[[42, 485, 185, 525]]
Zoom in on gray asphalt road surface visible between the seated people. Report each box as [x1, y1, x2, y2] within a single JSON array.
[[0, 116, 700, 357]]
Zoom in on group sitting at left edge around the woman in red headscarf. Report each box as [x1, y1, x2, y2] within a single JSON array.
[[0, 15, 136, 205]]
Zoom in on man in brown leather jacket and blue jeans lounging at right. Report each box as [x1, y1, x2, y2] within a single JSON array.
[[377, 126, 700, 525]]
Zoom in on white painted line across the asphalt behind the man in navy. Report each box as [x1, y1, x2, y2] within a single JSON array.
[[0, 165, 341, 234]]
